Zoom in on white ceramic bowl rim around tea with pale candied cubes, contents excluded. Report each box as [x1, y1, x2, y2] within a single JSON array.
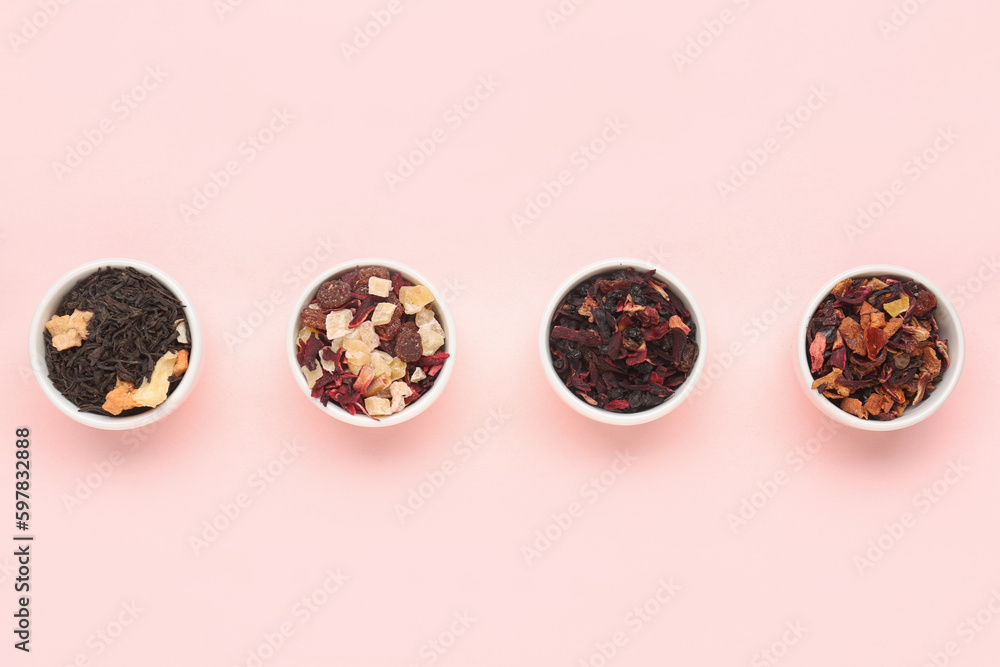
[[285, 258, 455, 427]]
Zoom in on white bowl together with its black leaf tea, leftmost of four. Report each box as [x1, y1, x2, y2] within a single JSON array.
[[28, 259, 202, 430]]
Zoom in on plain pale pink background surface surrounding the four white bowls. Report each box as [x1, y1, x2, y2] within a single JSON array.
[[0, 0, 1000, 667]]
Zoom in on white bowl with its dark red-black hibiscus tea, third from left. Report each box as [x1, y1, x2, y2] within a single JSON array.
[[538, 259, 707, 425]]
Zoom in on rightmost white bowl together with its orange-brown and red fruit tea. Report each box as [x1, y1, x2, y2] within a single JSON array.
[[798, 265, 965, 431]]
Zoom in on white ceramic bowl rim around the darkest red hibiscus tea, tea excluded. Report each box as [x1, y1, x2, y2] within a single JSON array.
[[538, 258, 708, 426]]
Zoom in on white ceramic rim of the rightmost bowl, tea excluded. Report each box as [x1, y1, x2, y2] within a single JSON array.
[[795, 264, 965, 431]]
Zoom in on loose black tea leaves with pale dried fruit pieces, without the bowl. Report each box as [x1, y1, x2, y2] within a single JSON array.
[[43, 267, 191, 416]]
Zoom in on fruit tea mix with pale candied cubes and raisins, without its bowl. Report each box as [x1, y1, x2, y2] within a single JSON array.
[[296, 266, 449, 419]]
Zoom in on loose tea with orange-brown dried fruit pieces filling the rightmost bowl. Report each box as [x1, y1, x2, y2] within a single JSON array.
[[805, 276, 949, 421]]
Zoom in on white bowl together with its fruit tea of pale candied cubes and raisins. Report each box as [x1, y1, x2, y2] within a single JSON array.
[[288, 259, 455, 426]]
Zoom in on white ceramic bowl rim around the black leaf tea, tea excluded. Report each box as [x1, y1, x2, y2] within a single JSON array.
[[28, 258, 204, 431]]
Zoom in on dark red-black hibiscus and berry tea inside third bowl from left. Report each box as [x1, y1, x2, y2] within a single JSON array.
[[549, 268, 698, 413]]
